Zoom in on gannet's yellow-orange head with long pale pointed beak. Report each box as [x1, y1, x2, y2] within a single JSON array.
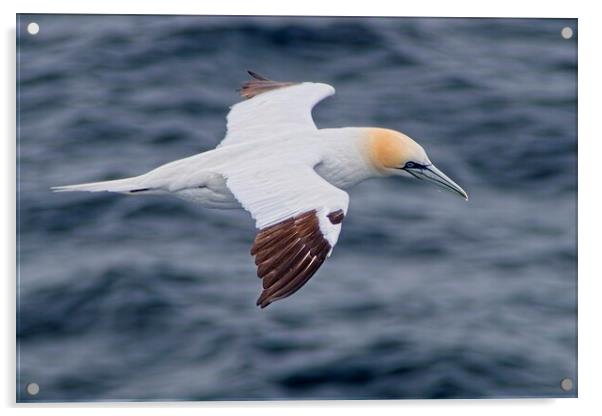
[[368, 128, 468, 199]]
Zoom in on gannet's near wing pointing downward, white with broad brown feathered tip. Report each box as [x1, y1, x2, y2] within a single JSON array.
[[226, 166, 349, 308]]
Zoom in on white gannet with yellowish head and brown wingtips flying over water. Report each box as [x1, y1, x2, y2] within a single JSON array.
[[52, 71, 468, 308]]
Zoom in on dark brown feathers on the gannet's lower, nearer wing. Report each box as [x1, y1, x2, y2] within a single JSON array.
[[251, 210, 344, 308]]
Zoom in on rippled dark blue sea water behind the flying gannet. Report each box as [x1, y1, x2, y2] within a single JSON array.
[[17, 15, 577, 401]]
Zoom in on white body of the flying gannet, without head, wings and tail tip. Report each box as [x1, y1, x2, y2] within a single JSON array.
[[102, 128, 378, 209]]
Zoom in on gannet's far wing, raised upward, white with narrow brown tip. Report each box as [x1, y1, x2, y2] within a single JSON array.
[[218, 71, 335, 147]]
